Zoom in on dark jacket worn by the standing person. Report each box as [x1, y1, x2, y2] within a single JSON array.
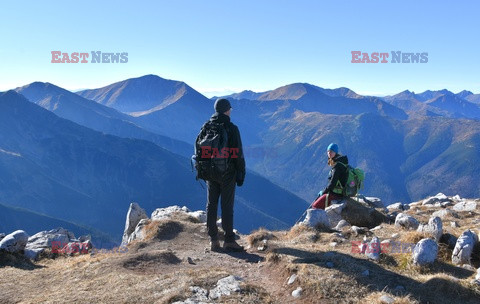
[[205, 113, 245, 184]]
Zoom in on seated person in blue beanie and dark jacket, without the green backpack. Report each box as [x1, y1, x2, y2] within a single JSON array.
[[312, 143, 348, 209]]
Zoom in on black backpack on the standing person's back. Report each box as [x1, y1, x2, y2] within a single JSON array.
[[193, 121, 229, 182]]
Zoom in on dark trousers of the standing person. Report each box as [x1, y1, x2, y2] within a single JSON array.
[[207, 176, 235, 242]]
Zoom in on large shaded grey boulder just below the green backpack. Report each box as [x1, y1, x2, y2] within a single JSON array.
[[341, 199, 388, 229]]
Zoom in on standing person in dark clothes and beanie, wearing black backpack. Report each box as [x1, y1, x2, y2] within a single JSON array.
[[195, 98, 245, 251]]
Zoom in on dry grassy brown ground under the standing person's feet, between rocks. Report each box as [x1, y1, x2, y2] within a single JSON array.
[[0, 208, 480, 303]]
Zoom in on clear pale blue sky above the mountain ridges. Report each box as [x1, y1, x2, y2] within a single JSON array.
[[0, 0, 480, 97]]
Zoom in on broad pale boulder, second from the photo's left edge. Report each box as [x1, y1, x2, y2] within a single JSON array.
[[25, 227, 75, 260]]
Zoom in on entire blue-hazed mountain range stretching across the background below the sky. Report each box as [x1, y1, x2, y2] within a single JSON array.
[[0, 75, 480, 247]]
